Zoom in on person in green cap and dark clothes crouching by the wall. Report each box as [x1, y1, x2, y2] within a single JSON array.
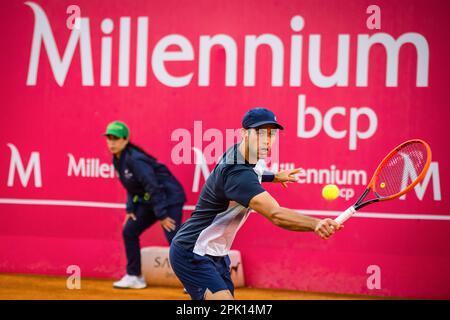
[[104, 121, 186, 289]]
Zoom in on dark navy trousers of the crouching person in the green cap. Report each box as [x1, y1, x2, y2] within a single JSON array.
[[122, 203, 183, 276]]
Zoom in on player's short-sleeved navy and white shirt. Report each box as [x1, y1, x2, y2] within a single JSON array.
[[173, 144, 266, 256]]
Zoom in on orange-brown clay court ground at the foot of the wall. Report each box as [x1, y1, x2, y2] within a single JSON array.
[[0, 274, 390, 300]]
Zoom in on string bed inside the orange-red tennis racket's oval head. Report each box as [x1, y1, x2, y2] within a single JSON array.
[[375, 141, 428, 197]]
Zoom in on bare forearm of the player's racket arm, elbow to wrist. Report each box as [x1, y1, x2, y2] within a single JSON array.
[[271, 207, 320, 231]]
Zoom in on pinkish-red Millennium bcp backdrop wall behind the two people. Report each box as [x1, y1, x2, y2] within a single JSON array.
[[0, 0, 450, 298]]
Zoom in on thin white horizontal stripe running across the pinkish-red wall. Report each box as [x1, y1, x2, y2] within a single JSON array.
[[0, 198, 450, 221]]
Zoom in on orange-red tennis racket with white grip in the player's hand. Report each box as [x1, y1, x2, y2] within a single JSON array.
[[334, 139, 431, 224]]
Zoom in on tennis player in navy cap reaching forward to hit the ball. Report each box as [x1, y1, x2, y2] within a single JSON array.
[[170, 108, 341, 300]]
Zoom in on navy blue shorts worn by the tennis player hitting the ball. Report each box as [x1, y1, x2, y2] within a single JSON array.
[[169, 242, 234, 300]]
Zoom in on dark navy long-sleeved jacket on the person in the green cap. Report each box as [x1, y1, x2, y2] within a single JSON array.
[[113, 145, 186, 219]]
